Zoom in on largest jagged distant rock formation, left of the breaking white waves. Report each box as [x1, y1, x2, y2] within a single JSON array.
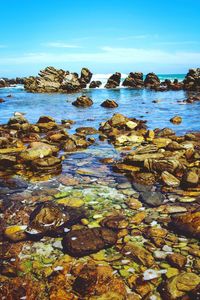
[[24, 67, 92, 93]]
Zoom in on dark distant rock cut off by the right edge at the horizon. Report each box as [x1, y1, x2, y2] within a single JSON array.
[[183, 68, 200, 91]]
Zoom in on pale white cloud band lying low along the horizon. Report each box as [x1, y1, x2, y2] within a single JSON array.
[[0, 46, 200, 66]]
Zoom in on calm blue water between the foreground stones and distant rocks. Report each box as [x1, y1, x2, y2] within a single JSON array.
[[0, 87, 200, 134]]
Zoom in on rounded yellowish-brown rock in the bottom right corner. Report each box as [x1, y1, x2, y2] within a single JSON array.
[[161, 272, 200, 300]]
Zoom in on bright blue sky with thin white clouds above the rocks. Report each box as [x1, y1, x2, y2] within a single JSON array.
[[0, 0, 200, 77]]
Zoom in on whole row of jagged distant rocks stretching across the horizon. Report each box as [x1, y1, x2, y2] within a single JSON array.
[[0, 66, 200, 93]]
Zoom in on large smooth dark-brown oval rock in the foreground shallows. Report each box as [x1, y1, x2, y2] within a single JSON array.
[[62, 228, 117, 257]]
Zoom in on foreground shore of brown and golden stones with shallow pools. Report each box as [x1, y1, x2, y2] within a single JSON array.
[[0, 107, 200, 300]]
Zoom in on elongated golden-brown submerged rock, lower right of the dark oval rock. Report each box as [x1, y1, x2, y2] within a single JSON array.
[[121, 242, 154, 267]]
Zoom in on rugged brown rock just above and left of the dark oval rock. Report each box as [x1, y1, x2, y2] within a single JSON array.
[[27, 203, 69, 235]]
